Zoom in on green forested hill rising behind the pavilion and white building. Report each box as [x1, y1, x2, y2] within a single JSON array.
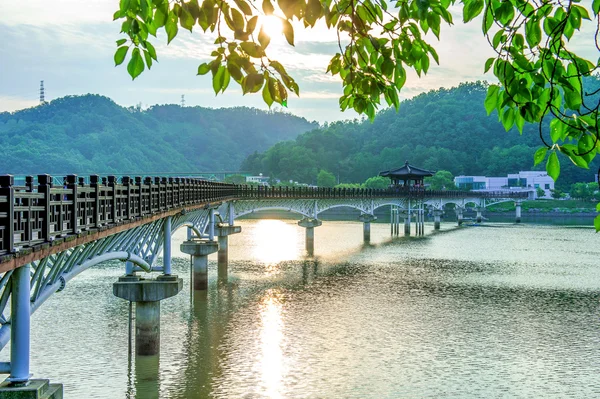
[[242, 82, 598, 187]]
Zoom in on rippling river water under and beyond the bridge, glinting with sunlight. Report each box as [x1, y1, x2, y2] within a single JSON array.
[[10, 220, 600, 399]]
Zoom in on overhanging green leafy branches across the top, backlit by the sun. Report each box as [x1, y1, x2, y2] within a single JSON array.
[[114, 0, 600, 184]]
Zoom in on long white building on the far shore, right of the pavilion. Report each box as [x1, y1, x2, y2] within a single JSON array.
[[454, 171, 554, 198]]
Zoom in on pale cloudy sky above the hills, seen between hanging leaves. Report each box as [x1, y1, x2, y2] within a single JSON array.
[[0, 0, 597, 123]]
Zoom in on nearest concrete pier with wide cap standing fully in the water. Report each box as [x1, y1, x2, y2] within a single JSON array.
[[113, 276, 183, 356]]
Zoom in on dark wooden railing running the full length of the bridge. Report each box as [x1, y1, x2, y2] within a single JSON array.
[[0, 175, 527, 262]]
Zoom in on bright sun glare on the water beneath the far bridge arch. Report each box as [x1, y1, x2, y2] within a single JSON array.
[[253, 220, 300, 273]]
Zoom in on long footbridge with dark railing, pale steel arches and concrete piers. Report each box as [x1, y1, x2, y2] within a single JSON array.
[[0, 175, 527, 398]]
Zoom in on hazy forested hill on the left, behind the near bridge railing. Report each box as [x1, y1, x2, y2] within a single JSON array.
[[0, 95, 318, 174]]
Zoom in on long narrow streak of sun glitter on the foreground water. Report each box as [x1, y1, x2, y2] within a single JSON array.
[[258, 290, 285, 398]]
